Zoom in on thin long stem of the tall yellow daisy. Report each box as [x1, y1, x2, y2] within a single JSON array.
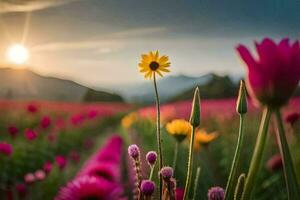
[[153, 72, 163, 199]]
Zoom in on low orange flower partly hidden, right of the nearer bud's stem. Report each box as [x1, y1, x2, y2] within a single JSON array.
[[194, 129, 219, 150]]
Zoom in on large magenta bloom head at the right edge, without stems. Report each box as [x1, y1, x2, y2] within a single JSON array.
[[237, 38, 300, 108]]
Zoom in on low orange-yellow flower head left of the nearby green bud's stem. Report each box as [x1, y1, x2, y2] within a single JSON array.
[[166, 119, 191, 142]]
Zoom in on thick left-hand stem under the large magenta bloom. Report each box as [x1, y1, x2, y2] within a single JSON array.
[[242, 108, 272, 200]]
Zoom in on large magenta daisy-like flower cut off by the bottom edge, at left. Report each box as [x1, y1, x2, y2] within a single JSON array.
[[55, 176, 122, 200]]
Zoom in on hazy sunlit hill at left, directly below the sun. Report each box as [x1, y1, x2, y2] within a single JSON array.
[[0, 68, 123, 102]]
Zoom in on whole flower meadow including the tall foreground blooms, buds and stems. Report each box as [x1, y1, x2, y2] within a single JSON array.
[[0, 38, 300, 200]]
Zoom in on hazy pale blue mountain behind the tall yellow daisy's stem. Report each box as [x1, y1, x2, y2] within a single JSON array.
[[115, 74, 214, 103]]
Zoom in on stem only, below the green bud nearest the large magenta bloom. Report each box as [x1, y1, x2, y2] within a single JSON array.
[[225, 114, 245, 200]]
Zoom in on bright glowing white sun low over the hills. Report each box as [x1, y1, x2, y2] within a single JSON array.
[[7, 44, 29, 65]]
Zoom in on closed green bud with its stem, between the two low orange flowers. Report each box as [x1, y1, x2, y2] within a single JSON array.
[[183, 87, 200, 200]]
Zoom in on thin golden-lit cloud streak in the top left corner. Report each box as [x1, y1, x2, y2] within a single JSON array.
[[0, 0, 78, 13]]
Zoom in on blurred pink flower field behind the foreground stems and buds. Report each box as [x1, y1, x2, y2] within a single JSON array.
[[0, 98, 300, 199]]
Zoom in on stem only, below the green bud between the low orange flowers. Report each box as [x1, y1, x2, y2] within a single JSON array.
[[183, 126, 195, 200]]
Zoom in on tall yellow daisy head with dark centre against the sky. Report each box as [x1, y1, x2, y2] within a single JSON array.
[[139, 51, 170, 79]]
